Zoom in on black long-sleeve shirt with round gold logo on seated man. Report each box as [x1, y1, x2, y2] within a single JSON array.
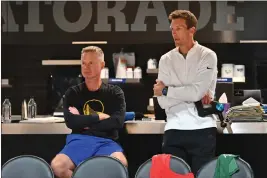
[[64, 82, 126, 139]]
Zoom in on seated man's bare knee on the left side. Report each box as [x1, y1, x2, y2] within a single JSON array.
[[51, 154, 72, 177]]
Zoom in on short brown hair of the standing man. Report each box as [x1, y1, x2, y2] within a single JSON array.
[[169, 10, 197, 29]]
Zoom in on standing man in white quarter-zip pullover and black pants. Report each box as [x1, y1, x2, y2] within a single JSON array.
[[154, 10, 217, 174]]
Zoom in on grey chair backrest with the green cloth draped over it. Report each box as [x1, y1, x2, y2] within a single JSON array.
[[196, 158, 254, 178]]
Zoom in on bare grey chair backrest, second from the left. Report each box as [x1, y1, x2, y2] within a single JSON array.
[[72, 156, 128, 178]]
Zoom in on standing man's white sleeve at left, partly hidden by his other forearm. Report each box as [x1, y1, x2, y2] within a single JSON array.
[[157, 56, 181, 109]]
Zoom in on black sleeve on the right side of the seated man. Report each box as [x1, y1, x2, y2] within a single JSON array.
[[91, 86, 126, 131]]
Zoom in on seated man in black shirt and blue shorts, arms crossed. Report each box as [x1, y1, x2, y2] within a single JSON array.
[[51, 46, 127, 178]]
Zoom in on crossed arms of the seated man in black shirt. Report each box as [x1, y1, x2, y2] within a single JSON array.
[[64, 89, 126, 131]]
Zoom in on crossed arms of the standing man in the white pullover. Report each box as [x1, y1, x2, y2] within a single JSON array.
[[153, 52, 217, 109]]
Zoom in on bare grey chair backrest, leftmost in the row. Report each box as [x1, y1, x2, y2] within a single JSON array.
[[2, 155, 54, 178]]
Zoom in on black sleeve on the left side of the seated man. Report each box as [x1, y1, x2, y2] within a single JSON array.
[[63, 88, 99, 129]]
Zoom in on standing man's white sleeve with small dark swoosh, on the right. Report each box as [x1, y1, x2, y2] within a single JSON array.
[[167, 52, 217, 102]]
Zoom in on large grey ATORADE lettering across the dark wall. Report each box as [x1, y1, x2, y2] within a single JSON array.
[[1, 1, 244, 33]]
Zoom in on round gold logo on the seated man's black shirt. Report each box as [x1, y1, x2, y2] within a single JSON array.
[[83, 99, 104, 115]]
